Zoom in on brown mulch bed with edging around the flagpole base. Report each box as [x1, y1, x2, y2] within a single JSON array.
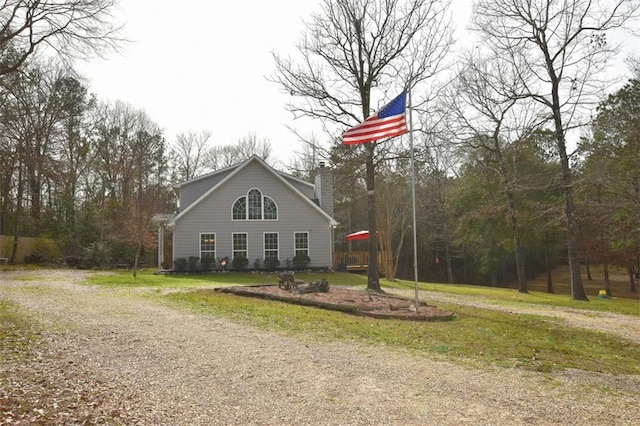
[[216, 285, 454, 321]]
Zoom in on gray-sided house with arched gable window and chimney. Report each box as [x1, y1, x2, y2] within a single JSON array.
[[167, 156, 337, 267]]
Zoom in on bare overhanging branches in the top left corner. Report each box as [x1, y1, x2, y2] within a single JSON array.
[[0, 0, 123, 76]]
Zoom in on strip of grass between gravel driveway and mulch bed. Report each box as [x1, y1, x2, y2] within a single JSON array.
[[163, 289, 640, 374]]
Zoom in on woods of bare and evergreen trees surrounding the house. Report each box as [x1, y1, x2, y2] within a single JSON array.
[[0, 0, 640, 291]]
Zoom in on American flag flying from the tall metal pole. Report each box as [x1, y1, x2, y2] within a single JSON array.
[[342, 92, 407, 145]]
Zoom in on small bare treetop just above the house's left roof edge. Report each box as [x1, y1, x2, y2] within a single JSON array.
[[172, 130, 211, 180]]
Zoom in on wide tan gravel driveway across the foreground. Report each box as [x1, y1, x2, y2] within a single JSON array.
[[0, 271, 640, 425]]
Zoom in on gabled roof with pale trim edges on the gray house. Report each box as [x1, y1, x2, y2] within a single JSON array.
[[169, 155, 338, 226]]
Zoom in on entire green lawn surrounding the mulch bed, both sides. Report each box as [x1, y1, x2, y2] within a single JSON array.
[[13, 271, 640, 375]]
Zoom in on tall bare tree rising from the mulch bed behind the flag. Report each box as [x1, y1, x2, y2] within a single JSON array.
[[272, 0, 452, 291]]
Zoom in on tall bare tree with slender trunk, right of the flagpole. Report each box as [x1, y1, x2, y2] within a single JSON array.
[[472, 0, 640, 300]]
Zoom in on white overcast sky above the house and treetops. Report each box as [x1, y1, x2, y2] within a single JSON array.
[[77, 0, 636, 163]]
